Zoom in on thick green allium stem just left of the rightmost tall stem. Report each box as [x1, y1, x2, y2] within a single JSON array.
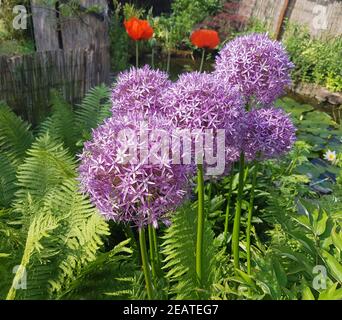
[[232, 152, 245, 269]]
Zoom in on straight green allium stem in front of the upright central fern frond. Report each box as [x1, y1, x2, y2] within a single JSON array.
[[196, 164, 204, 285]]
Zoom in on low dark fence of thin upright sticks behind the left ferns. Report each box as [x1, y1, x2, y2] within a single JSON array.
[[0, 47, 110, 124]]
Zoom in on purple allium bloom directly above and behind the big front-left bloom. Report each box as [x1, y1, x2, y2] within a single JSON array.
[[111, 65, 171, 116]]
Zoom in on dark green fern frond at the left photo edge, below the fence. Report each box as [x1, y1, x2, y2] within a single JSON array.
[[0, 102, 33, 164]]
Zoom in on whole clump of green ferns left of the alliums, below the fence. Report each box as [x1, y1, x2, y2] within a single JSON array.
[[0, 86, 141, 299]]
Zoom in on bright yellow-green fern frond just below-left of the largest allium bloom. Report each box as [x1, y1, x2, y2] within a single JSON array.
[[49, 179, 109, 294]]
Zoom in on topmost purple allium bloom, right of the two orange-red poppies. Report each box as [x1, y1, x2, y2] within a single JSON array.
[[214, 34, 294, 105]]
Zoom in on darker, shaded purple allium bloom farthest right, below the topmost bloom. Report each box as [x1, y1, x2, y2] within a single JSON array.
[[243, 107, 296, 160]]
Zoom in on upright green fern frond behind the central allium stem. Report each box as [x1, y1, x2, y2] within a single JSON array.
[[162, 204, 217, 299]]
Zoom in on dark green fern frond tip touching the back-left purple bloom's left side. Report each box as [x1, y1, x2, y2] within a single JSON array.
[[75, 84, 111, 139]]
